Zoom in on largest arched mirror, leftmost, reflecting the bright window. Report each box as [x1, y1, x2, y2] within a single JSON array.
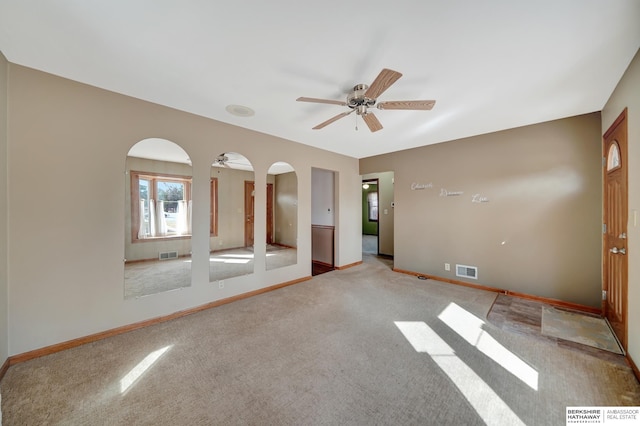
[[124, 138, 192, 299]]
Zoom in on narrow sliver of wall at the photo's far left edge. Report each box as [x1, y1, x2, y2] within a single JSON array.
[[0, 52, 9, 364]]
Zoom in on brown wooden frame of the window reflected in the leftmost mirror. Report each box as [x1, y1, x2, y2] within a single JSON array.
[[129, 170, 193, 243]]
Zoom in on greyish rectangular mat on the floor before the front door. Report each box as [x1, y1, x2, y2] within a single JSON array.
[[542, 306, 623, 355]]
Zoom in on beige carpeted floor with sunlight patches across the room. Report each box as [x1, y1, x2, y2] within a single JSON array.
[[0, 255, 640, 426]]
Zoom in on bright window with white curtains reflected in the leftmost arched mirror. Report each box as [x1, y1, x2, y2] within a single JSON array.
[[131, 171, 191, 241]]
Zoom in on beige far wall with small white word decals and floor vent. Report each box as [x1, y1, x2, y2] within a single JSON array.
[[360, 113, 602, 307]]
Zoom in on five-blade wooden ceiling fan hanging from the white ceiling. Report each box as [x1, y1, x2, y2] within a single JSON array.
[[296, 68, 436, 132]]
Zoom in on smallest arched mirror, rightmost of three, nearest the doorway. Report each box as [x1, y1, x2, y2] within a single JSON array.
[[266, 162, 298, 270]]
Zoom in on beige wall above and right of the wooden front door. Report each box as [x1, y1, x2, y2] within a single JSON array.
[[602, 53, 640, 365]]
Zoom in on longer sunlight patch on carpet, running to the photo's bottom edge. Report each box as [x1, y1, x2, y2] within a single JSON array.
[[395, 321, 524, 426]]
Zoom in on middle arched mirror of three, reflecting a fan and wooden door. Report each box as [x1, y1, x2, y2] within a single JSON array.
[[209, 152, 255, 282]]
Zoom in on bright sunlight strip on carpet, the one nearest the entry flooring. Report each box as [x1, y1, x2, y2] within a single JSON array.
[[438, 302, 538, 391]]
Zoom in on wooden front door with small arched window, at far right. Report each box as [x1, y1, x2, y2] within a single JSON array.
[[602, 109, 628, 350]]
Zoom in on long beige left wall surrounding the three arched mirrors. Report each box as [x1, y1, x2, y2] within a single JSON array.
[[6, 64, 361, 355]]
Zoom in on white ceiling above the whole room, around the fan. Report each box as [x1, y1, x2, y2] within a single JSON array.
[[0, 0, 640, 158]]
